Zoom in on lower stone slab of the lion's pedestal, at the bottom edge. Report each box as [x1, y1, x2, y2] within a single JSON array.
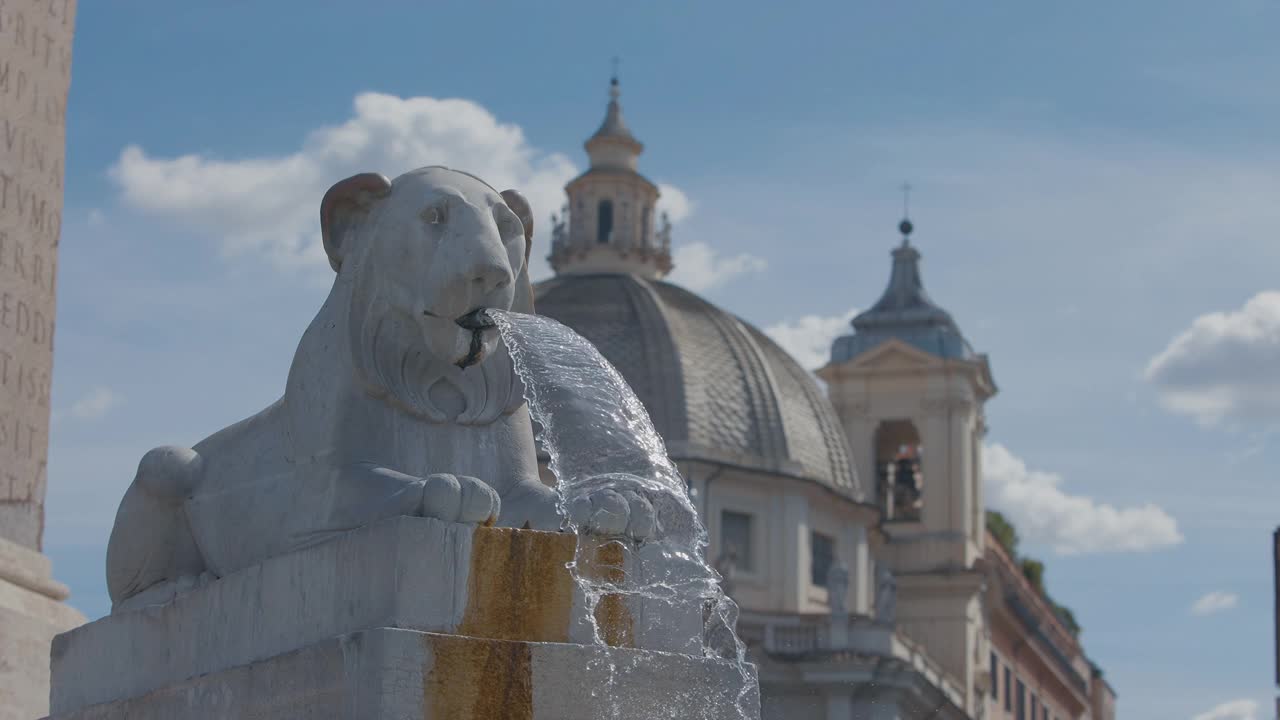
[[51, 628, 759, 720]]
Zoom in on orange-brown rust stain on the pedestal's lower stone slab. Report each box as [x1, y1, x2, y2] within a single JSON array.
[[422, 633, 534, 720]]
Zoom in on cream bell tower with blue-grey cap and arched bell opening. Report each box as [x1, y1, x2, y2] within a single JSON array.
[[818, 211, 996, 710]]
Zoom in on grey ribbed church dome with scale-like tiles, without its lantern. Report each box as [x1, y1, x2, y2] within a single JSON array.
[[535, 273, 864, 500]]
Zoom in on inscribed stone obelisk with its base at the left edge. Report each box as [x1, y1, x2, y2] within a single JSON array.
[[0, 0, 83, 720]]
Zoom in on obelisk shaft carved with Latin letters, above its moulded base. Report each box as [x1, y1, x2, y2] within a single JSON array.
[[0, 0, 76, 548]]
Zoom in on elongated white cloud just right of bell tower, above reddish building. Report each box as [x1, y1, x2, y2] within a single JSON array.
[[983, 443, 1183, 555]]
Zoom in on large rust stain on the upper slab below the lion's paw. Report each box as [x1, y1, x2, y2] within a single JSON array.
[[457, 520, 577, 642]]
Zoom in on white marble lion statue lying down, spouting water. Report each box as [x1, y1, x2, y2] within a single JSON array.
[[106, 167, 657, 611]]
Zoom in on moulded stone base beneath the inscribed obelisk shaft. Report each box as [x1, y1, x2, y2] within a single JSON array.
[[0, 539, 84, 720]]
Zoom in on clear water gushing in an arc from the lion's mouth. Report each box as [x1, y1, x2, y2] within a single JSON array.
[[488, 310, 756, 717]]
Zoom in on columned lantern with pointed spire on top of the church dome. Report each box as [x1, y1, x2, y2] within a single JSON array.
[[548, 74, 672, 279]]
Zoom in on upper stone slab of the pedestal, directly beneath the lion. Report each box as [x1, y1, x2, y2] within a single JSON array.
[[52, 518, 703, 714]]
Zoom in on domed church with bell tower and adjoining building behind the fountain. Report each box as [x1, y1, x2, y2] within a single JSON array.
[[535, 79, 1114, 720]]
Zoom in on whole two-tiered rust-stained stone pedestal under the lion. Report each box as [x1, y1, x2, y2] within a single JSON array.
[[51, 518, 759, 720]]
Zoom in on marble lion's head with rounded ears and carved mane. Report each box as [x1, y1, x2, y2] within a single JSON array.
[[320, 167, 532, 424]]
